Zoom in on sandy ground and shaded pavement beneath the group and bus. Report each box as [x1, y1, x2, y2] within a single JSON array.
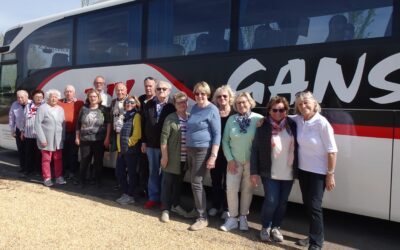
[[0, 149, 400, 249]]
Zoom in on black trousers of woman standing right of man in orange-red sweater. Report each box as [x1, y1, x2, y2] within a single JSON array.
[[79, 141, 104, 184]]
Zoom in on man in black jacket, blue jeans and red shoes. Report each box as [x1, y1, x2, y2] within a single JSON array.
[[142, 81, 175, 209]]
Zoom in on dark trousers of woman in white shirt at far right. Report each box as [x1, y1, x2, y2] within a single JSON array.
[[299, 169, 326, 247]]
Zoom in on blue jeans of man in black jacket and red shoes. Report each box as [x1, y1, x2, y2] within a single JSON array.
[[146, 148, 161, 202]]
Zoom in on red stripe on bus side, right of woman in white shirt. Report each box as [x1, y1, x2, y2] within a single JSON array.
[[332, 124, 400, 139]]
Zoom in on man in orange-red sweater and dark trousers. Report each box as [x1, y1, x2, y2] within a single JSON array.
[[58, 85, 83, 180]]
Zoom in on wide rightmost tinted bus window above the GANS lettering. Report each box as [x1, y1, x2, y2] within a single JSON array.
[[239, 0, 393, 50]]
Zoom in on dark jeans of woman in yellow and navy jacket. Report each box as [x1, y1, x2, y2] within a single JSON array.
[[115, 143, 140, 196]]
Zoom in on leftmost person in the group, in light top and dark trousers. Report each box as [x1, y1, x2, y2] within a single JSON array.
[[8, 90, 31, 173]]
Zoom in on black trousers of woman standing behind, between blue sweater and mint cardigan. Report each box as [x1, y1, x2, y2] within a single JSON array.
[[210, 153, 228, 211]]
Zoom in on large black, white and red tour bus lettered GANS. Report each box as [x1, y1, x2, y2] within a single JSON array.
[[0, 0, 400, 222]]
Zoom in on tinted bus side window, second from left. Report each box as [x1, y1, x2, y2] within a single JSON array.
[[77, 5, 142, 64]]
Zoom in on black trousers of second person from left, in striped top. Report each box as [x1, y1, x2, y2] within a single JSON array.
[[25, 138, 42, 173]]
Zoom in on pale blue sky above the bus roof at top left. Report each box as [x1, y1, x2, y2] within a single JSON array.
[[0, 0, 81, 35]]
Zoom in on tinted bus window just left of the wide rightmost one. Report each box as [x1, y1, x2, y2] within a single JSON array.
[[147, 0, 230, 58]]
